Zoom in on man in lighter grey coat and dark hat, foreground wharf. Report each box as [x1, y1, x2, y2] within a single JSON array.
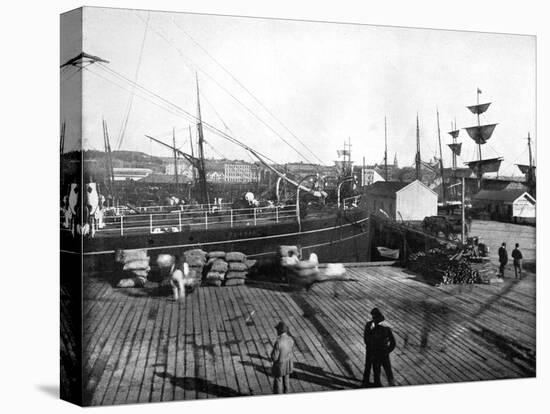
[[271, 321, 294, 394]]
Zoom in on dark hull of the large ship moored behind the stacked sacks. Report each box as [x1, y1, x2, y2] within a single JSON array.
[[61, 210, 370, 271]]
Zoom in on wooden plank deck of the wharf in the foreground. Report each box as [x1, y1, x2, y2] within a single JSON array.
[[83, 266, 536, 405]]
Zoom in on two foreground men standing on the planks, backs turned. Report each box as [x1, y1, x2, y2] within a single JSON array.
[[271, 308, 395, 394]]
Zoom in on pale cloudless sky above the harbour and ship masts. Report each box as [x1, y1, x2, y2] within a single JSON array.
[[61, 8, 536, 175]]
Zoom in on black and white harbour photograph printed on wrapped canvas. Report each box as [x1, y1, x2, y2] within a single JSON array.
[[56, 3, 541, 406]]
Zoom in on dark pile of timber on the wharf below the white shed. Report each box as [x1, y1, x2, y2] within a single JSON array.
[[406, 248, 484, 285]]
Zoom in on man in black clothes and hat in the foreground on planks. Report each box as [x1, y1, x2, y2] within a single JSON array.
[[363, 308, 395, 387]]
